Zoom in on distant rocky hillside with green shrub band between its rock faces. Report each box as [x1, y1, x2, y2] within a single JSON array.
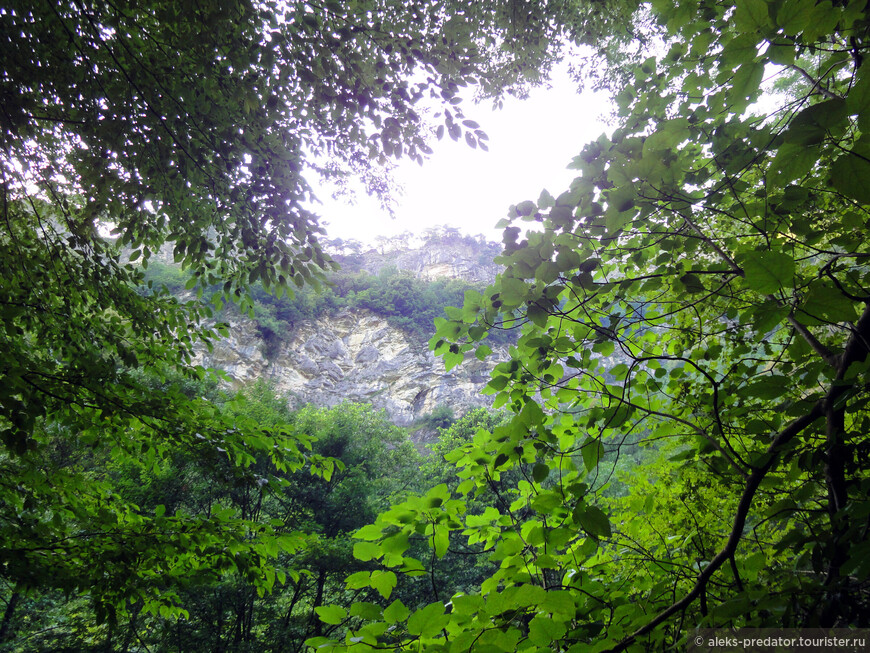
[[139, 233, 513, 426]]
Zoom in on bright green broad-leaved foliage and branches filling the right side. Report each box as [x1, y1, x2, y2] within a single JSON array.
[[309, 0, 870, 652]]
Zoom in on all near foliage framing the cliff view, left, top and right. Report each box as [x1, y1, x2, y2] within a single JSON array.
[[0, 0, 870, 652]]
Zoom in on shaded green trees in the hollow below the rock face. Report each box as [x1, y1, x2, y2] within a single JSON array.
[[0, 379, 510, 653]]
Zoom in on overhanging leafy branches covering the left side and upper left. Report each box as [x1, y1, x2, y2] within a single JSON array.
[[0, 0, 617, 639]]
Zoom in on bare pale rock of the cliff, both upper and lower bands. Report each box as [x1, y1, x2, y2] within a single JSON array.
[[197, 238, 506, 426]]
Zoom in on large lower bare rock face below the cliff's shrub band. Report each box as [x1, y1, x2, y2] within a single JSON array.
[[198, 310, 495, 426]]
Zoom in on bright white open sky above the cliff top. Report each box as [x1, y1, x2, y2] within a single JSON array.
[[315, 66, 608, 244]]
